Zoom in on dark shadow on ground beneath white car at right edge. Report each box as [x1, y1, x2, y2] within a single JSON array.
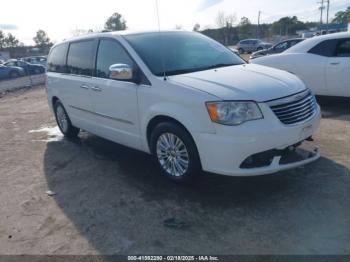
[[317, 96, 350, 121]]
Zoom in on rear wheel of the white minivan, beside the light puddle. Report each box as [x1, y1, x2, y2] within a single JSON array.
[[54, 100, 80, 138]]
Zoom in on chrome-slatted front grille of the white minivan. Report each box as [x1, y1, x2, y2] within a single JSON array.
[[268, 91, 317, 125]]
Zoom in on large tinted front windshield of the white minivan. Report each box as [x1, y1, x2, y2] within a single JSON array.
[[124, 32, 245, 76]]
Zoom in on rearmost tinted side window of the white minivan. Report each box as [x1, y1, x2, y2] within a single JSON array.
[[47, 43, 68, 73]]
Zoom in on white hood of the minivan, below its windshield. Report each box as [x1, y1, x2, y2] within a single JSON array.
[[168, 64, 305, 102]]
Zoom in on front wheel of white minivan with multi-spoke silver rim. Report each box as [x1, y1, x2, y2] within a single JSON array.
[[150, 122, 202, 182]]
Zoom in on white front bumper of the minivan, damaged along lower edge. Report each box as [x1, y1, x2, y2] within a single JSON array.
[[193, 103, 321, 176]]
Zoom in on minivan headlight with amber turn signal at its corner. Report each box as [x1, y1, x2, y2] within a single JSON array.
[[206, 101, 263, 126]]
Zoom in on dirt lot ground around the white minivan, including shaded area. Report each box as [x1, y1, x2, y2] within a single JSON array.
[[0, 87, 350, 255]]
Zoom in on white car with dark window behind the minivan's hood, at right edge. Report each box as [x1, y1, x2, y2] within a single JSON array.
[[251, 33, 350, 97]]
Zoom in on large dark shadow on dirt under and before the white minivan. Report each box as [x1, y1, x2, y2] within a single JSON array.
[[44, 133, 350, 254]]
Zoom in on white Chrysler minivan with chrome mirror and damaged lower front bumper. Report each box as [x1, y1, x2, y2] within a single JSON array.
[[47, 31, 320, 181]]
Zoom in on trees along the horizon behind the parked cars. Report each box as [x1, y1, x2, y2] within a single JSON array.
[[0, 6, 350, 52]]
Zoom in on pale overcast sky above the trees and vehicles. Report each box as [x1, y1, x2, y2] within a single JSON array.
[[0, 0, 350, 44]]
